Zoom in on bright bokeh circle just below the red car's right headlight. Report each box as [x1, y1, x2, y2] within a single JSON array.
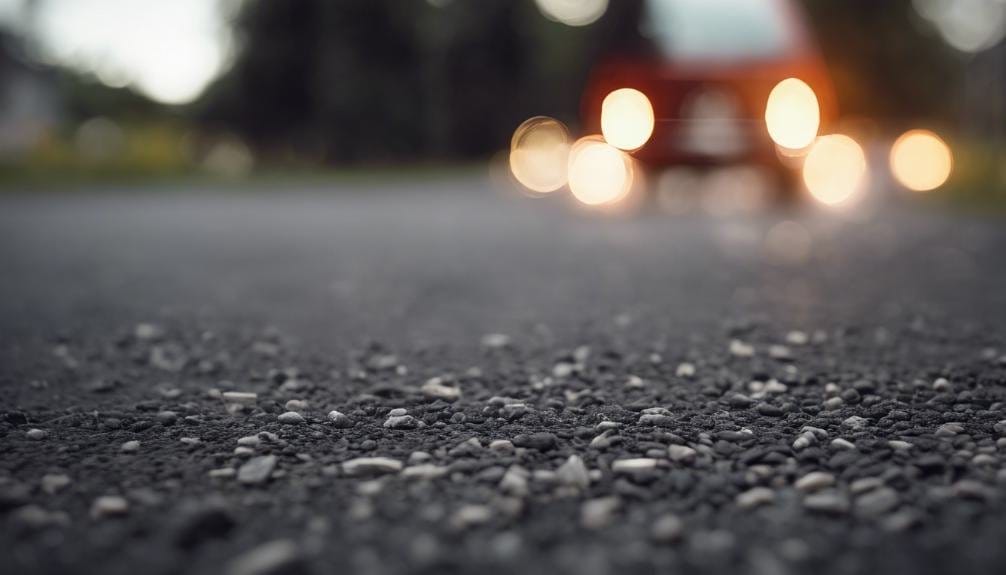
[[804, 134, 867, 205]]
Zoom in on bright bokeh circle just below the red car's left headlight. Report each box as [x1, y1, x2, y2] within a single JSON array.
[[569, 136, 634, 206]]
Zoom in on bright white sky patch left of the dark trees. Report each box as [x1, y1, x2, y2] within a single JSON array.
[[0, 0, 234, 104]]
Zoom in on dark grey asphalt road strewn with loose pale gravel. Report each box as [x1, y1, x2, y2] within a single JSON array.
[[0, 178, 1006, 575]]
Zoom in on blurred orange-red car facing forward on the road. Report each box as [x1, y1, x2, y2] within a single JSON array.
[[581, 0, 836, 172]]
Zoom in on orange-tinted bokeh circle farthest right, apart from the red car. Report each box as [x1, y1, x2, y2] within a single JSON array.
[[890, 130, 954, 192]]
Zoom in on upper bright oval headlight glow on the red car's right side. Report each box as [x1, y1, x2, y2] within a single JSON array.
[[765, 77, 821, 150]]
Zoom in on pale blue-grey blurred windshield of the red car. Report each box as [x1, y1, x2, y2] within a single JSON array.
[[643, 0, 793, 58]]
